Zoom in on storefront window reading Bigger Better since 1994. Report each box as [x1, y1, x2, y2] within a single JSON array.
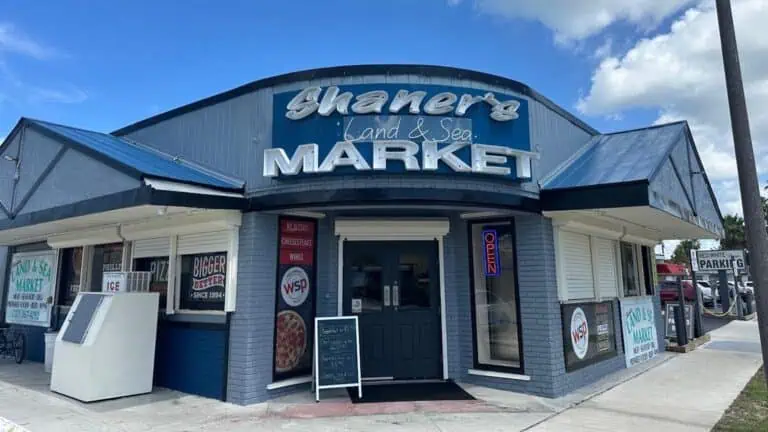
[[179, 252, 227, 311]]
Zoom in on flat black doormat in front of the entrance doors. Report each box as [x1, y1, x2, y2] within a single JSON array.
[[347, 381, 475, 404]]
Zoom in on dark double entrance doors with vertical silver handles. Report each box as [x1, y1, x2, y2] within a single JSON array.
[[343, 241, 442, 379]]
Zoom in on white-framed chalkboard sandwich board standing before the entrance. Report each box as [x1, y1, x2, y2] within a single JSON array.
[[315, 316, 363, 401]]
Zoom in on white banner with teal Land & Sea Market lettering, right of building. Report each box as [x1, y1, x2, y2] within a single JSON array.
[[621, 297, 659, 367]]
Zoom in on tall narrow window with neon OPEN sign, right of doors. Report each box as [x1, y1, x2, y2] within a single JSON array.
[[471, 222, 522, 369]]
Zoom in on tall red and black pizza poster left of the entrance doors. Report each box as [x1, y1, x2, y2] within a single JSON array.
[[274, 218, 317, 381]]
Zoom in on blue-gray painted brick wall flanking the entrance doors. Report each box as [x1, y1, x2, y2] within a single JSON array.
[[228, 213, 640, 404]]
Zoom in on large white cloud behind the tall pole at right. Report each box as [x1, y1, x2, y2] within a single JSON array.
[[577, 0, 768, 221]]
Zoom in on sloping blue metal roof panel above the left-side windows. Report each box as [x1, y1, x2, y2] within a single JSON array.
[[29, 120, 244, 190]]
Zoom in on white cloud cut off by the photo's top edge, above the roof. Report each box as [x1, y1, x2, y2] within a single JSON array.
[[448, 0, 692, 43]]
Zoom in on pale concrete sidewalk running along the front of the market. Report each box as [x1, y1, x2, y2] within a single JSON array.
[[0, 322, 760, 432]]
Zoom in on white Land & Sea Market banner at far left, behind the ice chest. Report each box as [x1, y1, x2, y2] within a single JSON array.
[[5, 251, 57, 327]]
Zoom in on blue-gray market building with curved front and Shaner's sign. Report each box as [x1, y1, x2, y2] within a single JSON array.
[[0, 65, 722, 404]]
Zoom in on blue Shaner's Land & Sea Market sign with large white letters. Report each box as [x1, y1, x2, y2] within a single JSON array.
[[270, 84, 538, 178]]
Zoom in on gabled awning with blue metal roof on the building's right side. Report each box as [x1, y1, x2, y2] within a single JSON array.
[[541, 122, 723, 240]]
